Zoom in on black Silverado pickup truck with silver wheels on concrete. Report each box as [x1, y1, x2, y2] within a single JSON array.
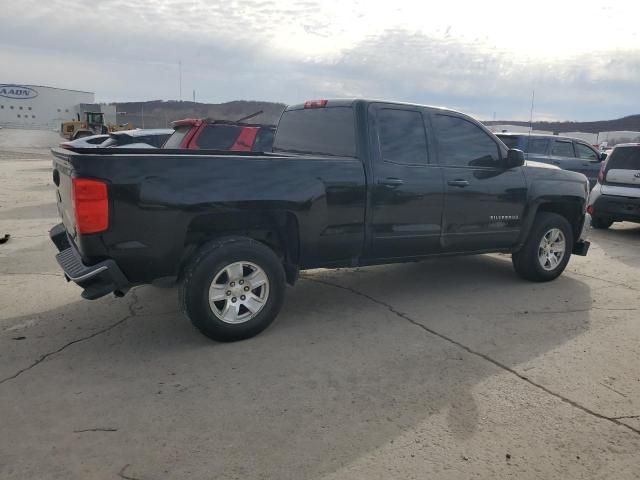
[[50, 100, 589, 341]]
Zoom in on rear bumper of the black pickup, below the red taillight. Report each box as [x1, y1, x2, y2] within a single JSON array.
[[49, 223, 131, 300]]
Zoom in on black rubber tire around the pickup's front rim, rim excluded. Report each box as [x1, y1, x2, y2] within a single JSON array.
[[511, 212, 573, 282]]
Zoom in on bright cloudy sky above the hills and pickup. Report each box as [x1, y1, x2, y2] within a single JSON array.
[[0, 0, 640, 121]]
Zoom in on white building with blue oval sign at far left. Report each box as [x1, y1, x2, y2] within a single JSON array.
[[0, 84, 95, 130]]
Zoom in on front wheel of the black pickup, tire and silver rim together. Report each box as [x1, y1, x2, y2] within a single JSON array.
[[511, 212, 573, 282]]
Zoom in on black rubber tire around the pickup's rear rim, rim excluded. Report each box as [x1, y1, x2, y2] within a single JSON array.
[[180, 237, 285, 342]]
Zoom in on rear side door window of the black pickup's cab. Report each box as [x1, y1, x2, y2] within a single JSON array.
[[378, 108, 428, 165]]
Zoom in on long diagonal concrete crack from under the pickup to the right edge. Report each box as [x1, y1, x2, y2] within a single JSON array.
[[300, 275, 640, 435]]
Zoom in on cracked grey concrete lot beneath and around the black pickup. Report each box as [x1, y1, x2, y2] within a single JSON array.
[[0, 129, 640, 480]]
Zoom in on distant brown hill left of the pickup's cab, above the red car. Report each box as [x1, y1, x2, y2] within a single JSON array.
[[112, 100, 285, 128]]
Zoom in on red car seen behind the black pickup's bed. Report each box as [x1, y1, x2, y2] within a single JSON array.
[[164, 118, 276, 152]]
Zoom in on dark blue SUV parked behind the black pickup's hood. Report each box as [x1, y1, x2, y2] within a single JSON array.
[[497, 133, 606, 188]]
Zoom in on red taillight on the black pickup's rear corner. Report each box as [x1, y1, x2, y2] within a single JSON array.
[[73, 178, 109, 233]]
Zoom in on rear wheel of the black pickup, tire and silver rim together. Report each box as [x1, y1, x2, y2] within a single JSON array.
[[180, 237, 285, 342]]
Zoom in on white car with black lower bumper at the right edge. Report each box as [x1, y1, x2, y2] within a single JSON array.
[[588, 143, 640, 228]]
